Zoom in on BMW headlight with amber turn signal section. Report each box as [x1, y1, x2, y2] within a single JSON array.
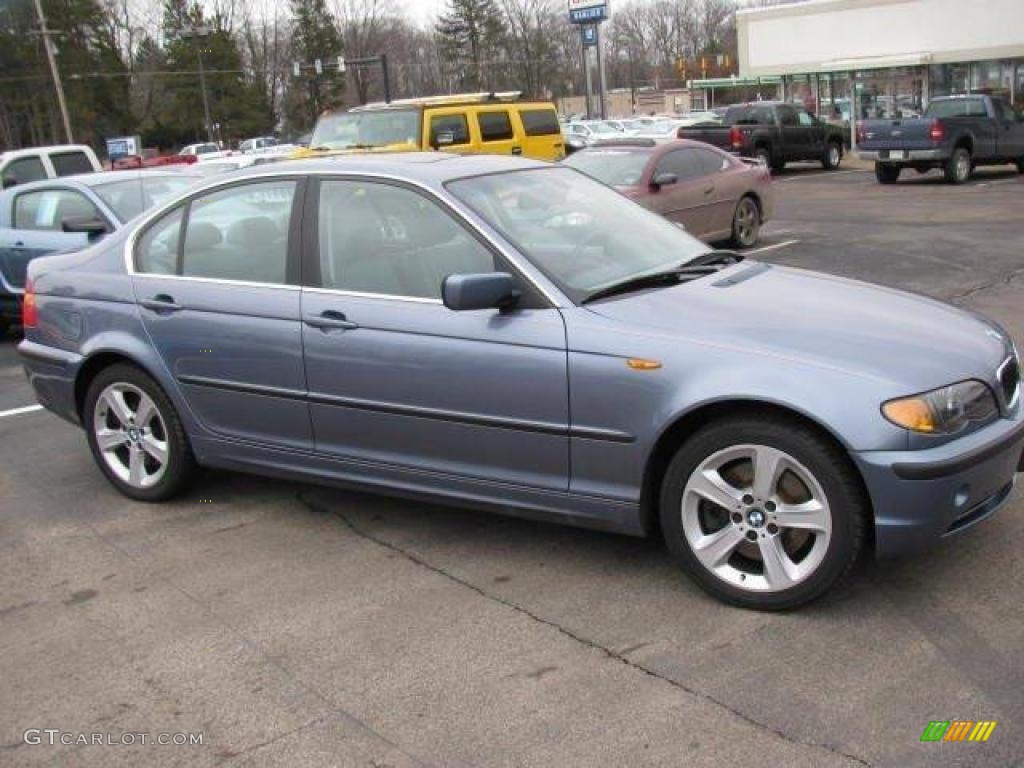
[[882, 380, 996, 434]]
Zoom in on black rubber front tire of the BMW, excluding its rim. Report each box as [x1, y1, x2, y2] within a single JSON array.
[[659, 415, 870, 610]]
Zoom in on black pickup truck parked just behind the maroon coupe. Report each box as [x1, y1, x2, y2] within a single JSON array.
[[678, 101, 843, 173]]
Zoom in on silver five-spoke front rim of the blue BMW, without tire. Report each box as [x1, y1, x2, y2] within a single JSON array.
[[681, 444, 833, 592]]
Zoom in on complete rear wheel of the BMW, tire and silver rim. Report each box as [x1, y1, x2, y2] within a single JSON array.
[[83, 365, 195, 501]]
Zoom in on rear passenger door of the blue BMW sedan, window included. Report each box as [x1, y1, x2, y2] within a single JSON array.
[[133, 178, 312, 450]]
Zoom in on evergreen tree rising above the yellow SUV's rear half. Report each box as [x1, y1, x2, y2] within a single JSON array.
[[437, 0, 502, 91]]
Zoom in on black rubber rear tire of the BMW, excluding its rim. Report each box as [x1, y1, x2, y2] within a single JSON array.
[[82, 364, 196, 502]]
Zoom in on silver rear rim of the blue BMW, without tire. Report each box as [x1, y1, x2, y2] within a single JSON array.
[[92, 382, 169, 489]]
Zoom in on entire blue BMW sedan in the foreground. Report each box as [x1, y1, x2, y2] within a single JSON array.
[[18, 154, 1024, 609]]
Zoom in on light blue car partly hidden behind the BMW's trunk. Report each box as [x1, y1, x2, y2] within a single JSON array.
[[0, 170, 202, 335]]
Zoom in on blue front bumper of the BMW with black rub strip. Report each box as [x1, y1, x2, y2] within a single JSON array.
[[853, 415, 1024, 557]]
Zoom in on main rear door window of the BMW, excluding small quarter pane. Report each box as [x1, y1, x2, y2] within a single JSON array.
[[180, 181, 296, 284]]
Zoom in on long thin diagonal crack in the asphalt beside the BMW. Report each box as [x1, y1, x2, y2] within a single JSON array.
[[297, 492, 871, 768]]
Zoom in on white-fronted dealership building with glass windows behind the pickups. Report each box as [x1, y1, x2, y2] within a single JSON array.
[[736, 0, 1024, 141]]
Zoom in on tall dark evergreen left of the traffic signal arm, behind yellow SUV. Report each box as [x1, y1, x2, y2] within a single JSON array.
[[291, 0, 345, 126]]
